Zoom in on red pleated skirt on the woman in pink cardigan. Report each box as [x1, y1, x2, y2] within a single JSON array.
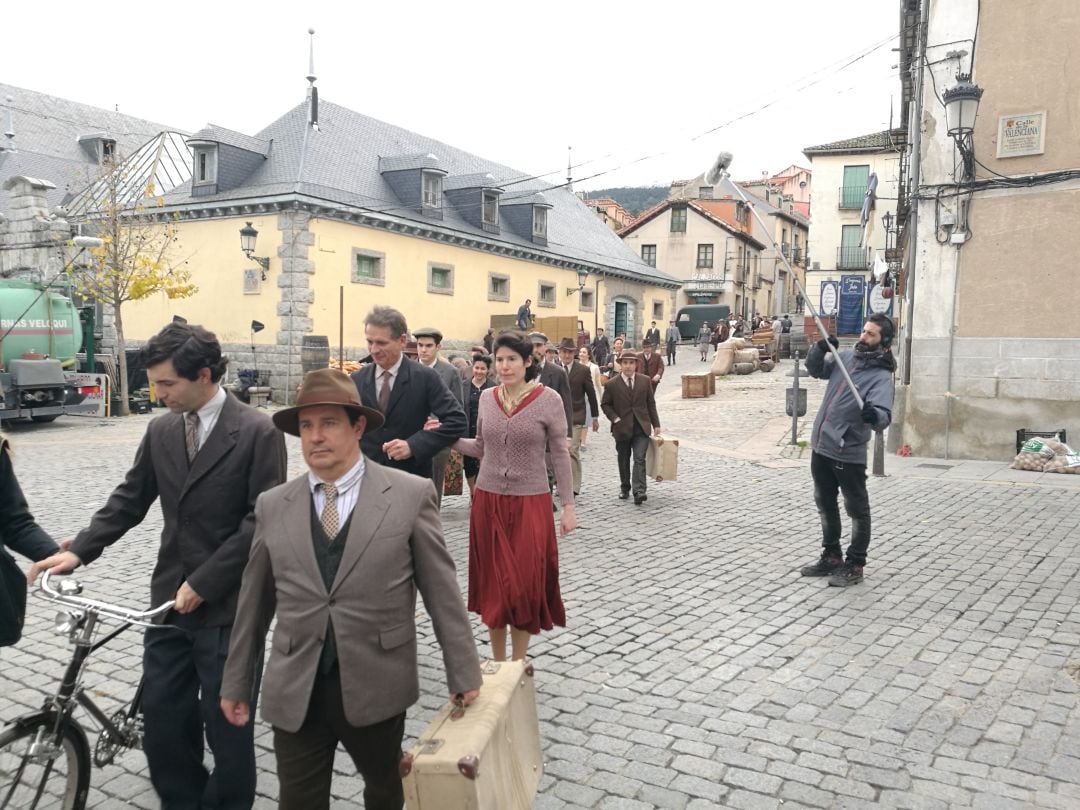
[[469, 488, 566, 635]]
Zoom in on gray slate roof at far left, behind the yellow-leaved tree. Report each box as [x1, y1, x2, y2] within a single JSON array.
[[0, 83, 182, 219]]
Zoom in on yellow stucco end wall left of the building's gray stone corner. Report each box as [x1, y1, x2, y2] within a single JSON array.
[[123, 214, 281, 345]]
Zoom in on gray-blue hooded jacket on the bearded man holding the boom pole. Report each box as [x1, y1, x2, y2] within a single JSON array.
[[807, 343, 896, 464]]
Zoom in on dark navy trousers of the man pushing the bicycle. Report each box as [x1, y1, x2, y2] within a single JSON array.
[[143, 615, 258, 810]]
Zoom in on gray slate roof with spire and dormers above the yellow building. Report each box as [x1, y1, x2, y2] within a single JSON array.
[[157, 98, 677, 285]]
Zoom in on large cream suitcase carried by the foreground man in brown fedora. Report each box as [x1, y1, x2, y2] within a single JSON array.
[[401, 661, 543, 810]]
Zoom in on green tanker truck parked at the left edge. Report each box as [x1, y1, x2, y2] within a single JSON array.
[[0, 279, 91, 422]]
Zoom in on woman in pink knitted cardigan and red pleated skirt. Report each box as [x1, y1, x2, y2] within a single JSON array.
[[454, 333, 578, 661]]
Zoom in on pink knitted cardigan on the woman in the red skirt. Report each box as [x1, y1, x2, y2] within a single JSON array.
[[454, 386, 573, 507]]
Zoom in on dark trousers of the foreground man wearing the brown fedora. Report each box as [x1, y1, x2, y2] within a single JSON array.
[[273, 665, 405, 810]]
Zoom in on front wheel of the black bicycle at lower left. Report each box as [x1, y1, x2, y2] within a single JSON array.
[[0, 715, 91, 810]]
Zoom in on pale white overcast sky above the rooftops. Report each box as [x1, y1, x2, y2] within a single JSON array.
[[0, 0, 900, 190]]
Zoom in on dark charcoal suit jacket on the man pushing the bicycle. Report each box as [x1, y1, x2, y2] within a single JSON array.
[[70, 394, 285, 626]]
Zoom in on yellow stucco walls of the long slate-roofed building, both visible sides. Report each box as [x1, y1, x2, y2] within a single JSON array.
[[124, 213, 671, 347]]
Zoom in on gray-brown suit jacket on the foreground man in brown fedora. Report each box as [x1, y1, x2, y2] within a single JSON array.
[[221, 463, 482, 731]]
